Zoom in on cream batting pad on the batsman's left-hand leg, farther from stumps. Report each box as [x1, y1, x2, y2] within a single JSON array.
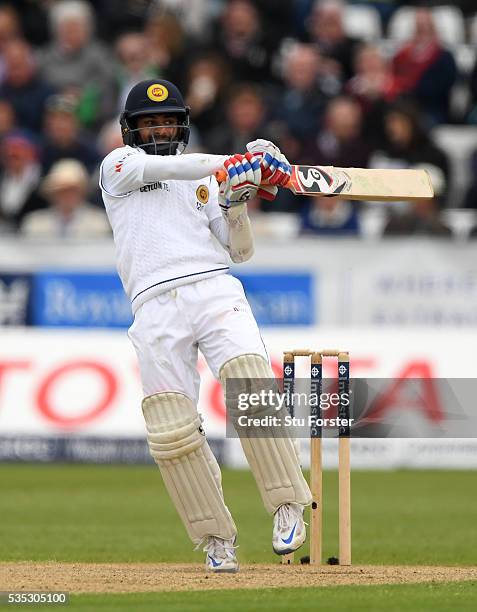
[[142, 392, 237, 544]]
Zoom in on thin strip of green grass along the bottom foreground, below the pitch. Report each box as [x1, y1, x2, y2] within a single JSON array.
[[4, 582, 477, 612]]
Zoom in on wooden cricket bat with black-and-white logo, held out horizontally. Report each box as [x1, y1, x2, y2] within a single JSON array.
[[215, 166, 434, 202]]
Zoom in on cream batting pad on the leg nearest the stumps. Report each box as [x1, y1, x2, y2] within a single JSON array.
[[220, 354, 311, 513]]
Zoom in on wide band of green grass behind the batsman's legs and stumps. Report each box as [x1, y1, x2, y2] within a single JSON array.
[[0, 465, 477, 565]]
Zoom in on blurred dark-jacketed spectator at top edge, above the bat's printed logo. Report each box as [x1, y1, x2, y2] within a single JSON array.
[[308, 0, 358, 83]]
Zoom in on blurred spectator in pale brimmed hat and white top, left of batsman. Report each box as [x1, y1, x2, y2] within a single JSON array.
[[21, 159, 110, 239]]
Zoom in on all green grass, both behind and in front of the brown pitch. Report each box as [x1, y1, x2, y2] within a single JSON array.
[[0, 465, 477, 612]]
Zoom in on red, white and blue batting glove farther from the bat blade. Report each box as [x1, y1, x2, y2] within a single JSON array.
[[219, 153, 262, 211]]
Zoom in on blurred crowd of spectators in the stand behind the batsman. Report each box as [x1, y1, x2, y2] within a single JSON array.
[[0, 0, 477, 238]]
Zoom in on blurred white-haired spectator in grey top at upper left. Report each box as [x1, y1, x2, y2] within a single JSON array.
[[40, 0, 116, 127]]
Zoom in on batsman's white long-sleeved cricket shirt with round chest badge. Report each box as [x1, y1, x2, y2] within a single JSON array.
[[100, 146, 230, 313]]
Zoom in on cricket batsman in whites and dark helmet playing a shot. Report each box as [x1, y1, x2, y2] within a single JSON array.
[[100, 79, 311, 572]]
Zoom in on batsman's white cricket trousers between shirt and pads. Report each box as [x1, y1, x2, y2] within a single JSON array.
[[128, 274, 268, 405]]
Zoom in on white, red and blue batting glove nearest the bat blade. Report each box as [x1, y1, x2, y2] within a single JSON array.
[[247, 138, 291, 200]]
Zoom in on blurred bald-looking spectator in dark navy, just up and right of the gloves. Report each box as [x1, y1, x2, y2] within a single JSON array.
[[273, 43, 333, 143]]
